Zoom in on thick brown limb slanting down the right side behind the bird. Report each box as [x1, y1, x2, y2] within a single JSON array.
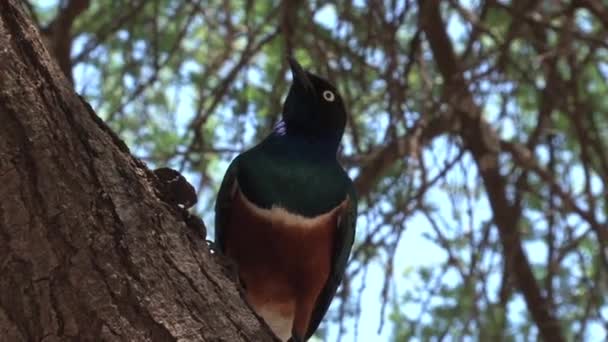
[[418, 0, 565, 341]]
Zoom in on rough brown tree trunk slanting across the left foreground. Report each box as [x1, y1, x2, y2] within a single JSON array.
[[0, 0, 273, 341]]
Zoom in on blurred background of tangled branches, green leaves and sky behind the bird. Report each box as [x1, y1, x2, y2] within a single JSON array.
[[10, 0, 608, 341]]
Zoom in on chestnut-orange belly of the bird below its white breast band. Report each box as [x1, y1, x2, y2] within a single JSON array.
[[225, 184, 347, 341]]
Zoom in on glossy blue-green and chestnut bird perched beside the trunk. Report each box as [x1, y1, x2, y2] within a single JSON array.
[[215, 58, 357, 342]]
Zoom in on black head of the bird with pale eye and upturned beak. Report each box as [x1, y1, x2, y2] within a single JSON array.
[[283, 57, 346, 146]]
